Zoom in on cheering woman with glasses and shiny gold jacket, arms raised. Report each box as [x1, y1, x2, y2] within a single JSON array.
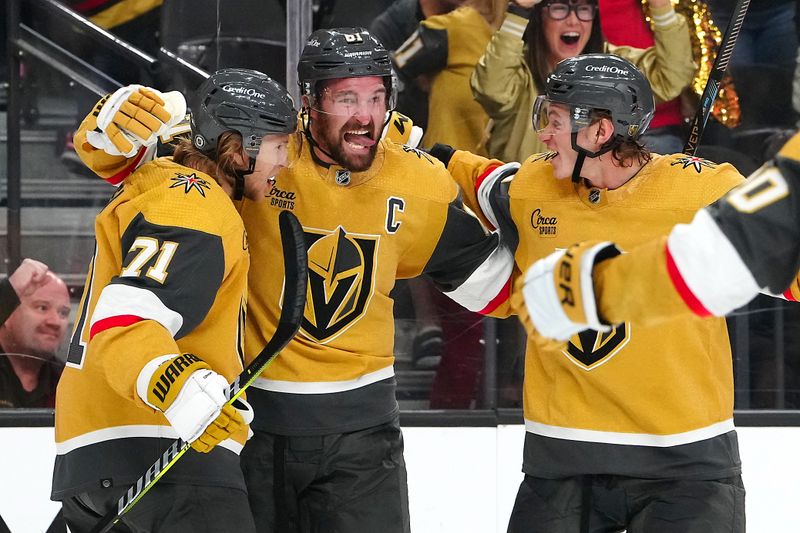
[[471, 0, 694, 161]]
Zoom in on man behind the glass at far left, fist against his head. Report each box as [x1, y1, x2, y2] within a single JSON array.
[[0, 259, 70, 407]]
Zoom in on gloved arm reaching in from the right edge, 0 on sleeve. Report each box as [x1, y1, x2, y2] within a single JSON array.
[[516, 128, 800, 338]]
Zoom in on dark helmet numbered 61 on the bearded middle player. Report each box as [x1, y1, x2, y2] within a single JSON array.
[[297, 27, 397, 109]]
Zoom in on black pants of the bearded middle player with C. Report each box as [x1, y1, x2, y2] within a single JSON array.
[[242, 421, 410, 533]]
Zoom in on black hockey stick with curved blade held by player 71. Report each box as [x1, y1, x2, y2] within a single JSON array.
[[91, 211, 308, 533]]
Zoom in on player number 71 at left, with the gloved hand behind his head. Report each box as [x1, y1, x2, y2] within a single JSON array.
[[52, 69, 297, 532]]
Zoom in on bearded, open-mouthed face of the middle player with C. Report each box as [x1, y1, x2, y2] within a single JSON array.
[[311, 76, 387, 171]]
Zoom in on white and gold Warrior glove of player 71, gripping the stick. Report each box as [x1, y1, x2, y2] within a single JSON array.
[[136, 354, 252, 453]]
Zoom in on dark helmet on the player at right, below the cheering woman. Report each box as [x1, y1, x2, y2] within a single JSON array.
[[533, 54, 655, 146]]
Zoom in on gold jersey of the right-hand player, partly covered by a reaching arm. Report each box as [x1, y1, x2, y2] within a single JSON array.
[[448, 152, 743, 479]]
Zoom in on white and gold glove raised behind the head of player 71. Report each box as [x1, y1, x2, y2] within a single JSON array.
[[86, 85, 186, 158]]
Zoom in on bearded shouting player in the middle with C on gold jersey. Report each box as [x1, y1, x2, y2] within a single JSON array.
[[242, 28, 511, 533]]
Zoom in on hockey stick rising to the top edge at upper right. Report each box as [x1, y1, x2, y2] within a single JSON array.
[[683, 0, 750, 155]]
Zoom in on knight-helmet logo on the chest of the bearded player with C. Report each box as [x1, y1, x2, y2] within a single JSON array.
[[302, 226, 378, 344]]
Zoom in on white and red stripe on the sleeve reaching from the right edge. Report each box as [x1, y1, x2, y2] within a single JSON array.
[[667, 209, 761, 316]]
